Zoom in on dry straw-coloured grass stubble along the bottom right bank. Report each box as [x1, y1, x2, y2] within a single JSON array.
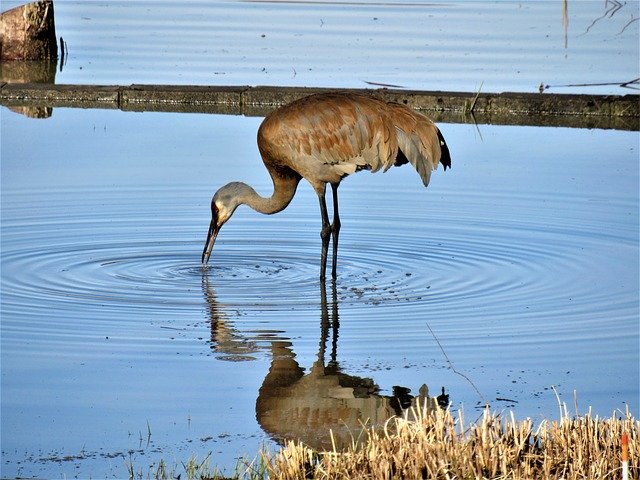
[[262, 407, 640, 480]]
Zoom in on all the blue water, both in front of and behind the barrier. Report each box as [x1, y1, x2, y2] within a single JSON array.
[[0, 1, 640, 478]]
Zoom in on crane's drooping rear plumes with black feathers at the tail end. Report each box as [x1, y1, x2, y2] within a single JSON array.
[[387, 103, 450, 187]]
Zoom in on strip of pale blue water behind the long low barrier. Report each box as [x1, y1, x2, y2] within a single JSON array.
[[2, 0, 640, 94]]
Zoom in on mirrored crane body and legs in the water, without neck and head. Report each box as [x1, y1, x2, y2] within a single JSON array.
[[256, 282, 436, 450]]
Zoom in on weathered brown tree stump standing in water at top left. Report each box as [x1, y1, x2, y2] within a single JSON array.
[[0, 0, 58, 61]]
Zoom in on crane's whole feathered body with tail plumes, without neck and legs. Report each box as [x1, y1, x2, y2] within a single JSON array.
[[258, 93, 450, 191]]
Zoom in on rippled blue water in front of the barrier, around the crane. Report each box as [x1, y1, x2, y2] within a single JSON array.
[[1, 109, 639, 478]]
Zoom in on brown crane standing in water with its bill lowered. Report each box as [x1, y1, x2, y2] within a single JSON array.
[[202, 93, 451, 279]]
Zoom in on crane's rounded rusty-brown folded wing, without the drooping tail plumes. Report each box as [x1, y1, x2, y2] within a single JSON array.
[[259, 94, 398, 183]]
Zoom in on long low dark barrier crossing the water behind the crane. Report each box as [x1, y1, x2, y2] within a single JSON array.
[[0, 83, 640, 130]]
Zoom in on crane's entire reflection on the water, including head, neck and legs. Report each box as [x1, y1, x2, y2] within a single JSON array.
[[202, 272, 449, 450]]
